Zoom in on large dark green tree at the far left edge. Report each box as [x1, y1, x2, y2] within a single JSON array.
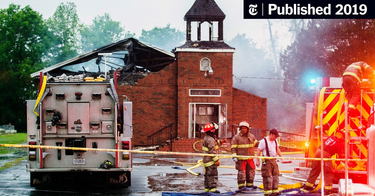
[[0, 4, 52, 131]]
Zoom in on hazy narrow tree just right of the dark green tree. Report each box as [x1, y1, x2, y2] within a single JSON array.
[[47, 2, 82, 65]]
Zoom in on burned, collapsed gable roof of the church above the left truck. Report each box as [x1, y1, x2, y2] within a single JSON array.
[[31, 38, 175, 77]]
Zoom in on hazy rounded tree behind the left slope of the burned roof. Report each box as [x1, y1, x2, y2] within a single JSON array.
[[81, 13, 134, 53]]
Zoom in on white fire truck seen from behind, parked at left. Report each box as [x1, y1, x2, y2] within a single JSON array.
[[26, 72, 132, 187]]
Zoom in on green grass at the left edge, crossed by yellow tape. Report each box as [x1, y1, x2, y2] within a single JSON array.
[[0, 133, 27, 171]]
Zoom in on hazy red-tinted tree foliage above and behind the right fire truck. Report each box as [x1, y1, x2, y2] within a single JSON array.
[[280, 19, 375, 93]]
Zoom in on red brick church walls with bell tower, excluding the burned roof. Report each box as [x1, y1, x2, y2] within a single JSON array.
[[118, 0, 267, 152]]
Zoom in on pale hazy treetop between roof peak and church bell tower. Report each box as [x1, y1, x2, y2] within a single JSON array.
[[139, 24, 185, 51]]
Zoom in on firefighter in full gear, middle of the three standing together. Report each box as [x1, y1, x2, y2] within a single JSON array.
[[231, 121, 258, 189]]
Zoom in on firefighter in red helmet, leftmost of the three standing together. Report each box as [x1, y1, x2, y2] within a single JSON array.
[[202, 123, 220, 193]]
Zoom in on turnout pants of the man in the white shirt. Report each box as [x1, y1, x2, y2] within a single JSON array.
[[262, 159, 279, 195]]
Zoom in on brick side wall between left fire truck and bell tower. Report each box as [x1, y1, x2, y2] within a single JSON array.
[[118, 63, 177, 146]]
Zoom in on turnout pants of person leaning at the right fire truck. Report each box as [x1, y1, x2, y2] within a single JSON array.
[[305, 149, 333, 191]]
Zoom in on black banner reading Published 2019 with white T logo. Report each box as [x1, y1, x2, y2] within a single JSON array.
[[243, 0, 375, 19]]
